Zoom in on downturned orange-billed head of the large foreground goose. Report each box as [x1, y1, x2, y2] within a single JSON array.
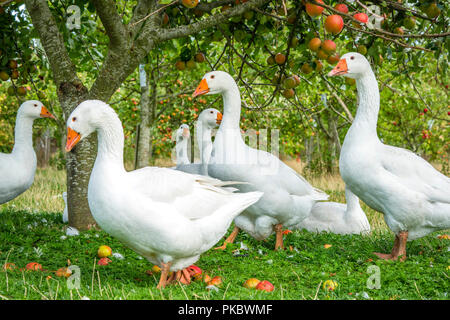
[[66, 100, 109, 152]]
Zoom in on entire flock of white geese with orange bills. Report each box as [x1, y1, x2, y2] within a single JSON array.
[[0, 53, 450, 287]]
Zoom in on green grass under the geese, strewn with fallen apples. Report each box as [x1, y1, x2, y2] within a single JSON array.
[[0, 169, 450, 299]]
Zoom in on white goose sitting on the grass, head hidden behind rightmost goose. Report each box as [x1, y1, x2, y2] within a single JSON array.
[[297, 187, 370, 234]]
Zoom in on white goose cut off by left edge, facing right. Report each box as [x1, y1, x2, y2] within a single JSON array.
[[0, 100, 55, 204]]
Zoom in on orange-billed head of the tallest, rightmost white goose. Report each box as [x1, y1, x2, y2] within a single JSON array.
[[328, 52, 372, 79]]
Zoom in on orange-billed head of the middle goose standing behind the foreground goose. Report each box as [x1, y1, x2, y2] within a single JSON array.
[[192, 71, 236, 98]]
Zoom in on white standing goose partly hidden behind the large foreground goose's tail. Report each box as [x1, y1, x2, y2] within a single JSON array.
[[193, 71, 328, 249]]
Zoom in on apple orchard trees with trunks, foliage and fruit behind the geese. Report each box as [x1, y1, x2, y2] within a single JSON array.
[[0, 0, 450, 229]]
